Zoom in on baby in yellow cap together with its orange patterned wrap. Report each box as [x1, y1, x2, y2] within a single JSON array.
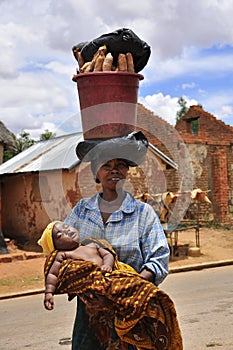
[[38, 221, 182, 350]]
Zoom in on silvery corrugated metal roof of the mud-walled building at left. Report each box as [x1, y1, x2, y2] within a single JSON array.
[[0, 132, 83, 175]]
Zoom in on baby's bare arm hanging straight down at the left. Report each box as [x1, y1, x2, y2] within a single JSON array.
[[44, 252, 67, 310]]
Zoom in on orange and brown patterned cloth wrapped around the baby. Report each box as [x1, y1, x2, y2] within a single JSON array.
[[44, 239, 183, 350]]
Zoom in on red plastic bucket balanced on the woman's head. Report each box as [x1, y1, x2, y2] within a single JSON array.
[[75, 72, 144, 139]]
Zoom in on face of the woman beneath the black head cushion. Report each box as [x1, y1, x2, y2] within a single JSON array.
[[96, 159, 129, 189]]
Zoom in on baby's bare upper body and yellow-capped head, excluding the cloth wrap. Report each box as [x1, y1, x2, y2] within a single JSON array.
[[38, 221, 115, 310]]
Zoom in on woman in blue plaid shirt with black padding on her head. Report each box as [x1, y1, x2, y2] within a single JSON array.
[[65, 131, 182, 350]]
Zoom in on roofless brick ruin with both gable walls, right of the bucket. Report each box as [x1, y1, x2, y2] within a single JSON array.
[[137, 104, 233, 224]]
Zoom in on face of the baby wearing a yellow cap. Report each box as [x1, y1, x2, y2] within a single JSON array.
[[53, 222, 80, 250]]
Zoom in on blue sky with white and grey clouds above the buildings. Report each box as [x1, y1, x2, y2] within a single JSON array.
[[0, 0, 233, 139]]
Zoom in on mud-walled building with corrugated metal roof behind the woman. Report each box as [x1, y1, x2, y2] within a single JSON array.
[[0, 127, 176, 249]]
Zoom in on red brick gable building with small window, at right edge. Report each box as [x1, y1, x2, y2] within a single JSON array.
[[176, 106, 233, 223]]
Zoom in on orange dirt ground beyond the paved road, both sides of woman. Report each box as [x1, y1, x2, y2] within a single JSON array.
[[0, 228, 233, 296]]
